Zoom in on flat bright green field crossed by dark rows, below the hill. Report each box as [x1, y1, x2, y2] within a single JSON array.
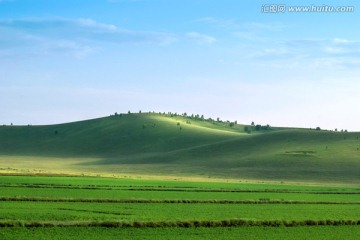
[[0, 176, 360, 239]]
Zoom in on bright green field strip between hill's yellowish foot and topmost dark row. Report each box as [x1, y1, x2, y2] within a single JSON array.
[[0, 175, 360, 192]]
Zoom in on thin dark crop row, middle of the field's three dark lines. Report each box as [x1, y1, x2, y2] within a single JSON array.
[[0, 197, 360, 205]]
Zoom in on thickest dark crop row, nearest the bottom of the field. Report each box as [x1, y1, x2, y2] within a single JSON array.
[[0, 219, 360, 228]]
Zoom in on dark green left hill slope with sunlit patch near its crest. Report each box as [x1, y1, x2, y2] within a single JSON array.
[[0, 114, 242, 157]]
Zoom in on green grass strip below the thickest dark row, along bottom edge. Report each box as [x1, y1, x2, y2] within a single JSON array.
[[0, 226, 360, 240]]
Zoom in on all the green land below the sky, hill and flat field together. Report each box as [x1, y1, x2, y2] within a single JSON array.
[[0, 113, 360, 239]]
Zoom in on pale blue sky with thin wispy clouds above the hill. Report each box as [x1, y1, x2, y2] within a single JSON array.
[[0, 0, 360, 131]]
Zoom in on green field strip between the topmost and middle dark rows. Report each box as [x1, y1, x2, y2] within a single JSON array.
[[0, 187, 360, 202]]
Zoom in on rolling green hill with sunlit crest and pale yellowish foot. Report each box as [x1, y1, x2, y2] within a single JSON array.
[[0, 113, 360, 184]]
